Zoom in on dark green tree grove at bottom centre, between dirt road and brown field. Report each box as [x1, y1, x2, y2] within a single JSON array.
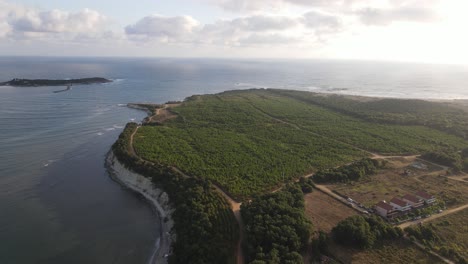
[[241, 185, 312, 264]]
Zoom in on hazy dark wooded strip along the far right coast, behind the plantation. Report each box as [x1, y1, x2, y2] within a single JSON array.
[[276, 90, 468, 138]]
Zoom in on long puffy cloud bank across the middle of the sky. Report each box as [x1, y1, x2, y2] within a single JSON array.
[[125, 12, 336, 46]]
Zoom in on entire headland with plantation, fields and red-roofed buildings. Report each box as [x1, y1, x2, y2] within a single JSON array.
[[108, 89, 468, 263]]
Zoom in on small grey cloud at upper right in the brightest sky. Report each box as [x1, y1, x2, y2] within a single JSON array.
[[357, 6, 439, 26]]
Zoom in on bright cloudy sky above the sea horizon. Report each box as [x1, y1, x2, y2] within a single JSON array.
[[0, 0, 468, 64]]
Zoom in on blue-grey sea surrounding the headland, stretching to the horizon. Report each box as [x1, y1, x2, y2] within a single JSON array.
[[0, 58, 468, 264]]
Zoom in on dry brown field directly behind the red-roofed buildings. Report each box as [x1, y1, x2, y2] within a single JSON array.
[[327, 157, 468, 207]]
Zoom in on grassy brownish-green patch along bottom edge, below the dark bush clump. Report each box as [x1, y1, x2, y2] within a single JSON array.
[[329, 239, 444, 264]]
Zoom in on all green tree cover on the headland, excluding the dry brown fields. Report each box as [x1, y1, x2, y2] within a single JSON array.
[[113, 89, 468, 264]]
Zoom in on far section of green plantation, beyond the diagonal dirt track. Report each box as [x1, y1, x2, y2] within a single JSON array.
[[241, 90, 467, 154]]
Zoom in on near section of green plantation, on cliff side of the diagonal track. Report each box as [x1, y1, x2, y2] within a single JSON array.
[[135, 91, 367, 198]]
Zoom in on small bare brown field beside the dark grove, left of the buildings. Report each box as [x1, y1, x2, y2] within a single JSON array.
[[304, 190, 357, 233]]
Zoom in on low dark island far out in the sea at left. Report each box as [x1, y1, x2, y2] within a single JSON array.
[[0, 77, 112, 87]]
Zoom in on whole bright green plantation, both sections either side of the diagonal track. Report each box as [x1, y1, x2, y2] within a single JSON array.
[[135, 90, 468, 198]]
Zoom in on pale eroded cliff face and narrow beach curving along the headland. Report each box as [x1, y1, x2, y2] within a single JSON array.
[[105, 150, 175, 264]]
